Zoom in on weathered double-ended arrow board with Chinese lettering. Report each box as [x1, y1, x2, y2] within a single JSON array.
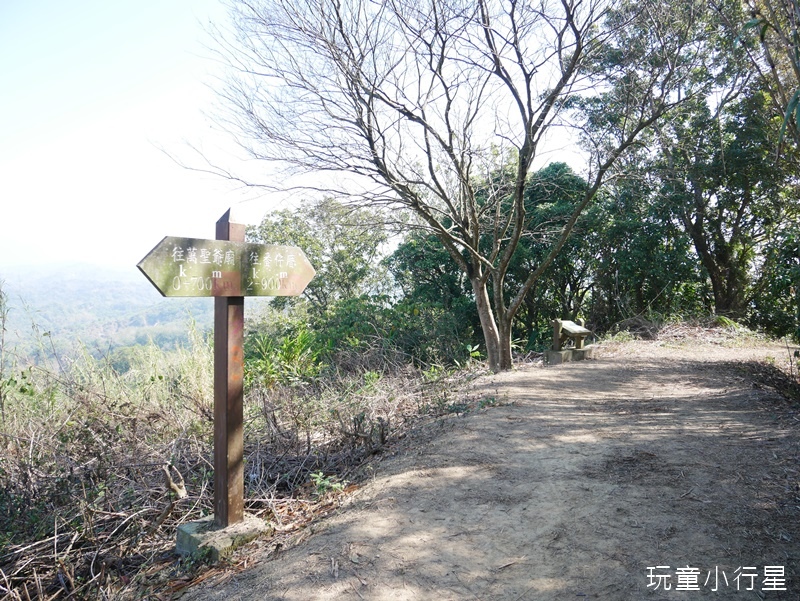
[[137, 236, 316, 296]]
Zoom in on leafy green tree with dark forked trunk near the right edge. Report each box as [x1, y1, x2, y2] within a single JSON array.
[[660, 89, 800, 319]]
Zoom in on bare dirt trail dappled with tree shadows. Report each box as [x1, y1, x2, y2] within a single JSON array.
[[182, 343, 800, 601]]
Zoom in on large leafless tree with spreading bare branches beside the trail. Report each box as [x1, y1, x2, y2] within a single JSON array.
[[218, 0, 707, 371]]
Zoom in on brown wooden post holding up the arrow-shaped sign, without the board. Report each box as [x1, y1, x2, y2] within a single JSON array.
[[214, 210, 245, 528]]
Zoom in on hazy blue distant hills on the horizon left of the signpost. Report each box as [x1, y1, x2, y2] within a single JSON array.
[[0, 264, 214, 358]]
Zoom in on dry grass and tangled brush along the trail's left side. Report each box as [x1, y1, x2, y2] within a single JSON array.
[[0, 316, 482, 600]]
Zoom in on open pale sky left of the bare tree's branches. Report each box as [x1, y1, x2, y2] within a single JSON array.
[[0, 0, 275, 276]]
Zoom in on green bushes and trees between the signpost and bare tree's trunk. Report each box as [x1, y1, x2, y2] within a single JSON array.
[[246, 200, 479, 368]]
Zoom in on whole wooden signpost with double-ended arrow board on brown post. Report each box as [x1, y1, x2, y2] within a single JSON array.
[[137, 211, 315, 528]]
